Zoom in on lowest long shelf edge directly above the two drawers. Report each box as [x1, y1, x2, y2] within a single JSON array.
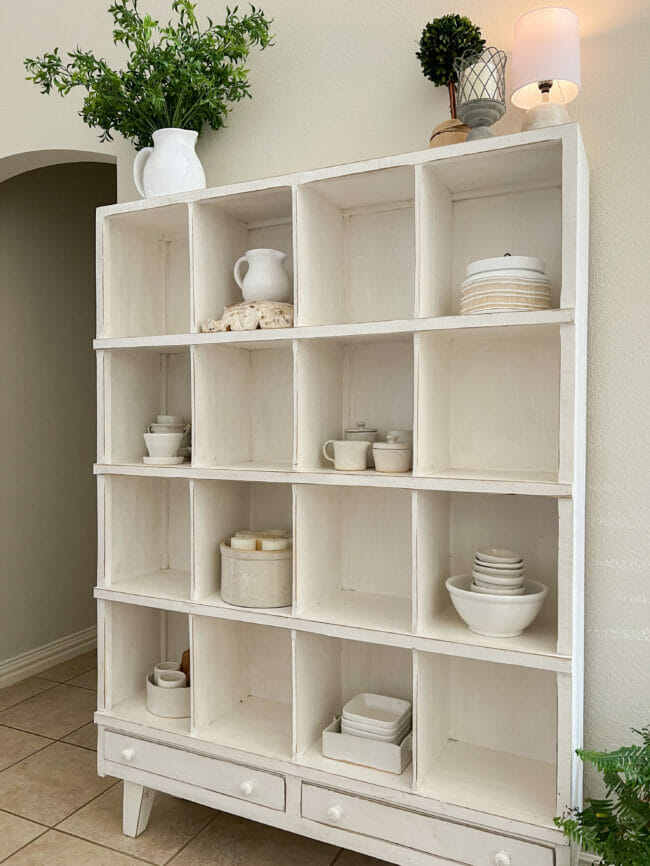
[[94, 707, 563, 844]]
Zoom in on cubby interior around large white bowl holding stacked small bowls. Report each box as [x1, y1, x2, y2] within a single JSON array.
[[415, 491, 559, 655]]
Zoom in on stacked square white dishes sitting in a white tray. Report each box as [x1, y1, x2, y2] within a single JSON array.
[[341, 692, 411, 743]]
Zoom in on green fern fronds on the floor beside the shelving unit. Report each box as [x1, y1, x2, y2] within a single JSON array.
[[554, 727, 650, 866]]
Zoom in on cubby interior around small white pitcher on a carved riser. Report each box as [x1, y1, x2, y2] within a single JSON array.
[[192, 186, 293, 331]]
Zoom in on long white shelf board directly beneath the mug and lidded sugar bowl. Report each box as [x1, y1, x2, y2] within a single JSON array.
[[94, 463, 573, 498]]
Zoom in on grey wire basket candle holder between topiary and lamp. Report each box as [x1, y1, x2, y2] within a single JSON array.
[[454, 48, 507, 141]]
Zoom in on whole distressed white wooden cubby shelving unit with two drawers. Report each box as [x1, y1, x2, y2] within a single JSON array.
[[95, 124, 588, 866]]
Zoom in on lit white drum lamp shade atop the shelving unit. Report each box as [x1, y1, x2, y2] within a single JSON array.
[[511, 6, 580, 108]]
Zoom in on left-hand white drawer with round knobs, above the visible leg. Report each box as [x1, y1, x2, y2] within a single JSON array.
[[104, 731, 285, 812]]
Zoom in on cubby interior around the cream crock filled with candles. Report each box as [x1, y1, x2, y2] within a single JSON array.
[[193, 481, 292, 614]]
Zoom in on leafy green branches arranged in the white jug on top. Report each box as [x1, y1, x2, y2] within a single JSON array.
[[24, 0, 272, 150]]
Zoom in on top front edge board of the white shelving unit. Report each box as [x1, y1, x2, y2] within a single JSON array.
[[98, 123, 581, 217]]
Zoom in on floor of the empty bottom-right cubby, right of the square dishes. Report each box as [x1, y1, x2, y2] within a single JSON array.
[[420, 740, 556, 827]]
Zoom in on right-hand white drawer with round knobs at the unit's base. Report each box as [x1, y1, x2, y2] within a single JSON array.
[[302, 784, 554, 866]]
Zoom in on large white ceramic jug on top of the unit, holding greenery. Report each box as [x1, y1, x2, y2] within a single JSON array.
[[133, 128, 205, 198]]
